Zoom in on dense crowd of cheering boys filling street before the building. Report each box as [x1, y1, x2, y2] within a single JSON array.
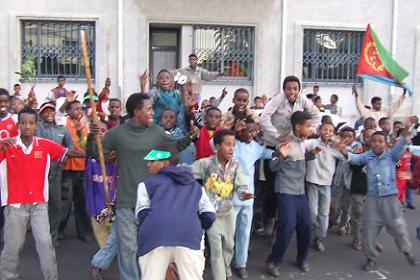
[[0, 63, 420, 280]]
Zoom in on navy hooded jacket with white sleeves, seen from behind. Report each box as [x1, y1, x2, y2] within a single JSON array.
[[136, 166, 216, 256]]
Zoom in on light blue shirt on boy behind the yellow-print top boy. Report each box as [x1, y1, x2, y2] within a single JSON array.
[[232, 140, 274, 206]]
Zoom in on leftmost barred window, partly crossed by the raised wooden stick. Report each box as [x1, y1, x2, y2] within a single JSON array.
[[21, 20, 95, 79]]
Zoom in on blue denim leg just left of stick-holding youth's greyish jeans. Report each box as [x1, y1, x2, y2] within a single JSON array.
[[91, 222, 118, 270]]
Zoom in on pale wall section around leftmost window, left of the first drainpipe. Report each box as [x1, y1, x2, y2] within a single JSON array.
[[0, 0, 119, 102]]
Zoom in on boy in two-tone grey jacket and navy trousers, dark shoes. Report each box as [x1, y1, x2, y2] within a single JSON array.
[[266, 111, 316, 277]]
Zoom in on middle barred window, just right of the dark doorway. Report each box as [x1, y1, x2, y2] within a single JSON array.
[[193, 25, 254, 84]]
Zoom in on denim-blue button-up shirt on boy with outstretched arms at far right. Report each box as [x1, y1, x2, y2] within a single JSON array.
[[348, 137, 407, 197]]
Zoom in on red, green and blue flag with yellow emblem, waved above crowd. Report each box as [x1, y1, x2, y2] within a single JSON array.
[[356, 24, 413, 96]]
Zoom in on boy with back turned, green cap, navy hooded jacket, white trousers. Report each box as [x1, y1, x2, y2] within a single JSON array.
[[135, 146, 216, 279]]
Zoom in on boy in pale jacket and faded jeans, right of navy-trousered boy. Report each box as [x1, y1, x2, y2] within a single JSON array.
[[306, 122, 344, 252]]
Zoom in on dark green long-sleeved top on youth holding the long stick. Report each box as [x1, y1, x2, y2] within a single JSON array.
[[102, 121, 191, 209]]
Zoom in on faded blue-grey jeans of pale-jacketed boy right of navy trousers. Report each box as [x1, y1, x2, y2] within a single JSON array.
[[306, 182, 331, 238]]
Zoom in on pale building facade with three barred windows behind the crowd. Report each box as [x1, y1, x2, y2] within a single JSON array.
[[0, 0, 420, 119]]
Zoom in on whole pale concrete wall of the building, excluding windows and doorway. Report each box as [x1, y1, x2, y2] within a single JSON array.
[[0, 0, 420, 119]]
